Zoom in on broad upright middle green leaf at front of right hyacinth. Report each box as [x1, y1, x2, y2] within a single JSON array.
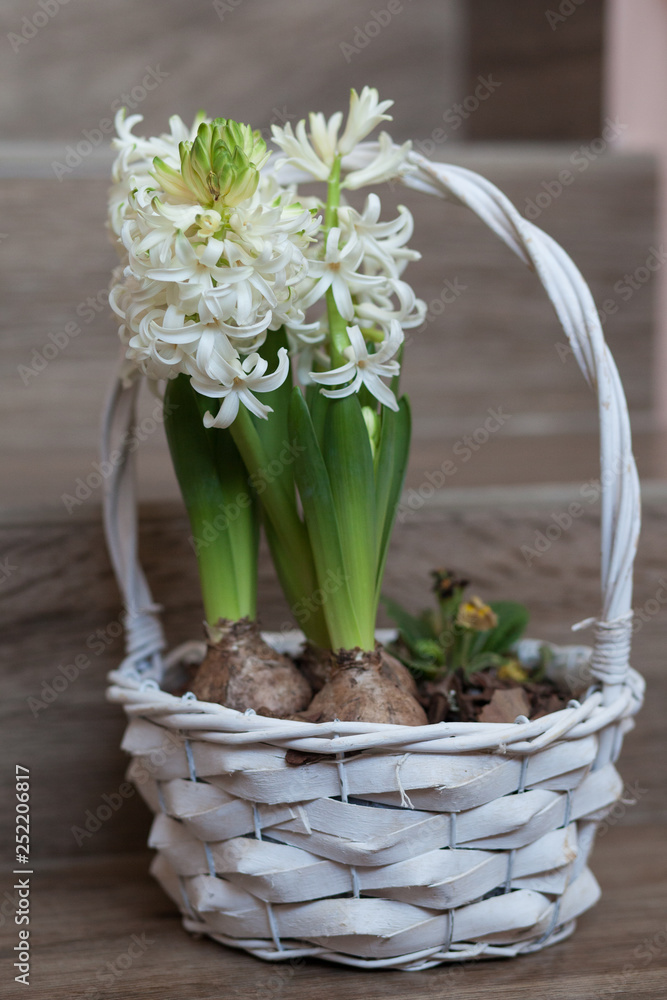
[[322, 396, 377, 649]]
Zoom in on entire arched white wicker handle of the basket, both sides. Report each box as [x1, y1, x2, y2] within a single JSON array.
[[102, 152, 640, 702]]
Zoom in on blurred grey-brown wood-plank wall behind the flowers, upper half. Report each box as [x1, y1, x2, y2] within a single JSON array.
[[0, 0, 660, 511]]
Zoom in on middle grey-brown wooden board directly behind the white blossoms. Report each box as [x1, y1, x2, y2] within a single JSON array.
[[0, 148, 666, 509]]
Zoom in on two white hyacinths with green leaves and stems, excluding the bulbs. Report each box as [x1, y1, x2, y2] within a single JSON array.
[[109, 88, 425, 724]]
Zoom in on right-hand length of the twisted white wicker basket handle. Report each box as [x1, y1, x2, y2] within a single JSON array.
[[403, 153, 641, 701]]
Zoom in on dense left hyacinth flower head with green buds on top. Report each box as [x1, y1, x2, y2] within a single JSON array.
[[109, 112, 321, 426]]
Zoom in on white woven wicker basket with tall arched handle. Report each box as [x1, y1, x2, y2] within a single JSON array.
[[103, 152, 643, 970]]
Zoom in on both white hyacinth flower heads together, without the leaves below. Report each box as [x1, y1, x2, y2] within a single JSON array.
[[109, 87, 426, 427]]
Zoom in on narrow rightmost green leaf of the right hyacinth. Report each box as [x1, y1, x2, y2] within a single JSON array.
[[375, 396, 412, 603]]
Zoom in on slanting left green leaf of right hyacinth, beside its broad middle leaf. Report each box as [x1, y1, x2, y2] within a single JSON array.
[[289, 387, 362, 649]]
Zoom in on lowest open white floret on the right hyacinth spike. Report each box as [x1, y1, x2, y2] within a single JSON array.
[[310, 321, 403, 410]]
